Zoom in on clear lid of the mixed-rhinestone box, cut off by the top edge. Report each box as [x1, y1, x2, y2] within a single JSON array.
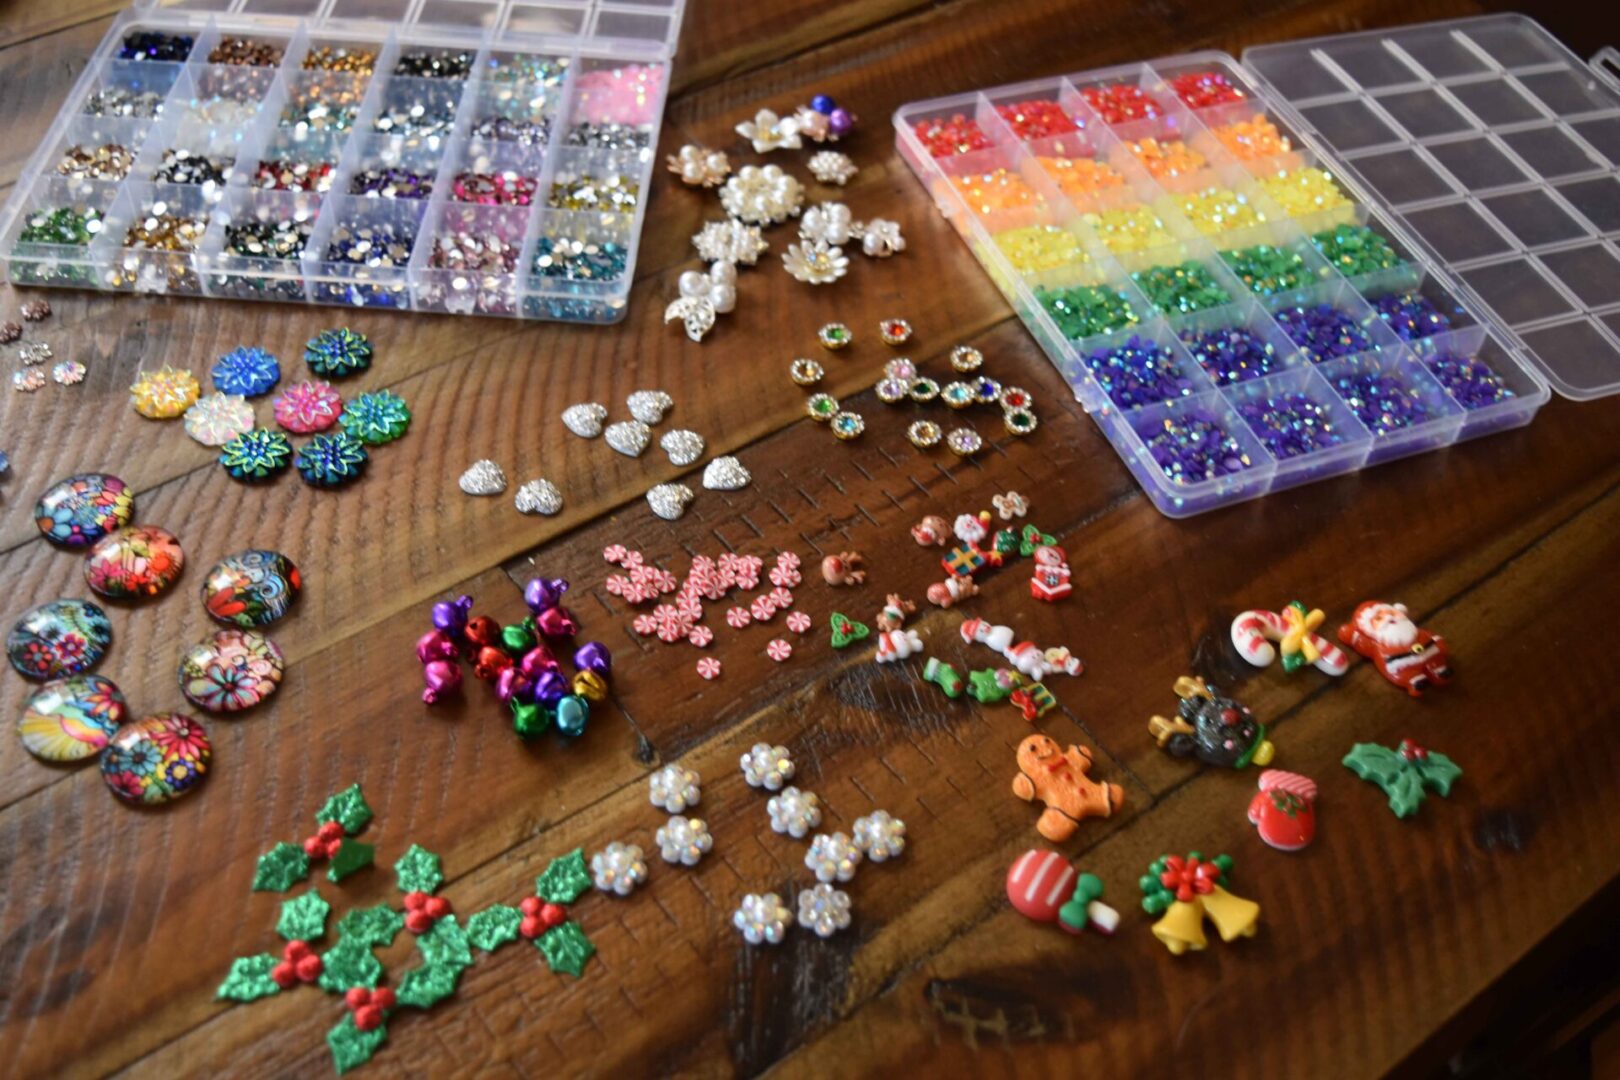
[[133, 0, 687, 60]]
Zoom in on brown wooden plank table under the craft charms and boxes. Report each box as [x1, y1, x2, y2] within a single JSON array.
[[0, 0, 1620, 1077]]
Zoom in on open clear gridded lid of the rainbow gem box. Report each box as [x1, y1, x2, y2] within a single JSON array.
[[1243, 15, 1620, 400]]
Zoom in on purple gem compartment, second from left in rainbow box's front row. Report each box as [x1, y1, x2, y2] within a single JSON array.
[[1226, 368, 1372, 491]]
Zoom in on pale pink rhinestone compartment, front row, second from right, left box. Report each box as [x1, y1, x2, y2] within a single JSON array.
[[415, 202, 531, 316]]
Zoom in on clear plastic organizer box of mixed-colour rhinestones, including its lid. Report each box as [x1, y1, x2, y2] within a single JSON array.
[[0, 0, 685, 322]]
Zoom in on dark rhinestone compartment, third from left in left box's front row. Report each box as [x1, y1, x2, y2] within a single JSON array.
[[203, 188, 321, 303]]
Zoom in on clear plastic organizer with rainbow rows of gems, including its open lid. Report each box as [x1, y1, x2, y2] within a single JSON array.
[[894, 16, 1620, 517]]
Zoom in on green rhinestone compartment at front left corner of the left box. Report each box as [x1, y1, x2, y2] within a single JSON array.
[[0, 176, 118, 288]]
